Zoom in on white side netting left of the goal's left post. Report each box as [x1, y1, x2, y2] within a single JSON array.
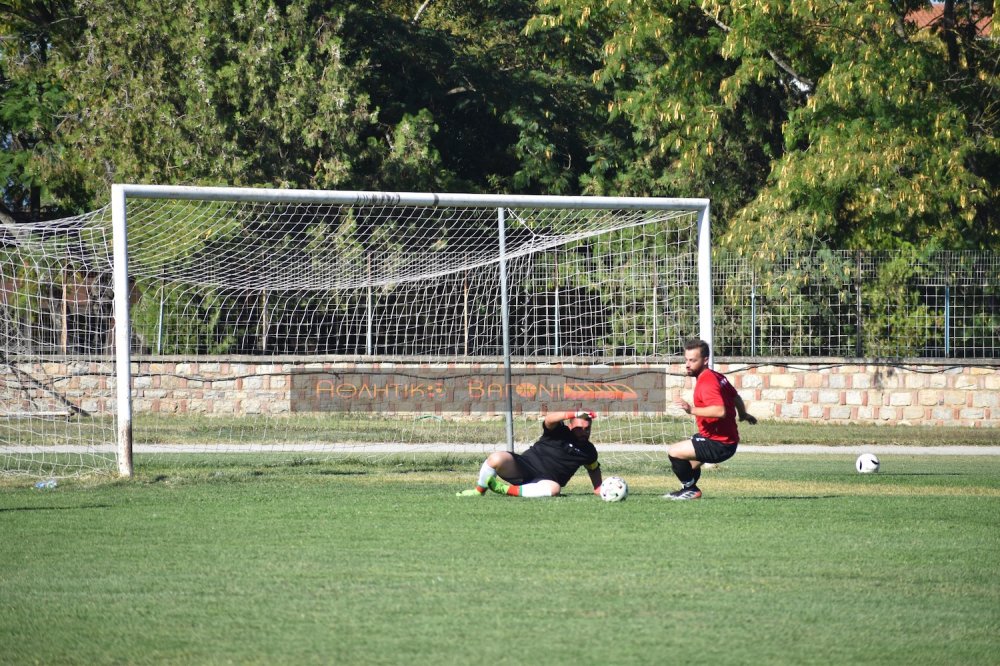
[[0, 214, 115, 476]]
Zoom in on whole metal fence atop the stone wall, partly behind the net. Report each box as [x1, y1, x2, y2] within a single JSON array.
[[0, 214, 1000, 361]]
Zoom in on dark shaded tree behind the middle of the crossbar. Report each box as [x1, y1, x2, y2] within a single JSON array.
[[346, 0, 606, 194]]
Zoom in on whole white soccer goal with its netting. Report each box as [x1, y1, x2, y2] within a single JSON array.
[[0, 185, 712, 476]]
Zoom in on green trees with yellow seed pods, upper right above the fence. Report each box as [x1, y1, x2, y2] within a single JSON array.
[[531, 0, 1000, 255]]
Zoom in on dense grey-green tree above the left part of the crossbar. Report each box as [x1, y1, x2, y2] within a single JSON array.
[[44, 0, 369, 194]]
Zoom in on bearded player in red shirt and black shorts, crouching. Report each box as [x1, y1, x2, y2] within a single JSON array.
[[664, 340, 757, 500]]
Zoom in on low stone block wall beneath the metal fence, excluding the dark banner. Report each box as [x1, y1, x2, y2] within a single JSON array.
[[9, 358, 1000, 428]]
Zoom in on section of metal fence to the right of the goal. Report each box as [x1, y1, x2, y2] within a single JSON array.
[[713, 251, 1000, 359]]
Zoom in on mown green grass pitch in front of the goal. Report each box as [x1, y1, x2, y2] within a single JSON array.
[[0, 454, 1000, 665]]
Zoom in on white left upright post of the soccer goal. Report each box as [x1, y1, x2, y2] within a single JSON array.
[[111, 185, 134, 477]]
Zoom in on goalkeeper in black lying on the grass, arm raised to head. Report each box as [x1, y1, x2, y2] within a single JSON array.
[[457, 412, 601, 497]]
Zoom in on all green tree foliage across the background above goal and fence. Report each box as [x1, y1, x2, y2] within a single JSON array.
[[0, 0, 1000, 360]]
